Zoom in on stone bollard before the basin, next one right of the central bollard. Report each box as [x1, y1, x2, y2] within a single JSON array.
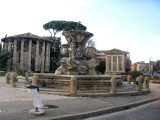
[[110, 77, 117, 94]]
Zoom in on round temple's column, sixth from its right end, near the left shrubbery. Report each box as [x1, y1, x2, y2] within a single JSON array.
[[13, 40, 17, 72]]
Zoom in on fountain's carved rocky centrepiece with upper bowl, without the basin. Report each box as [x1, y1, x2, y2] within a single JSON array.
[[55, 26, 99, 75]]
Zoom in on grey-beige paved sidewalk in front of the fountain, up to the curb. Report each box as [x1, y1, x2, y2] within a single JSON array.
[[0, 77, 160, 120]]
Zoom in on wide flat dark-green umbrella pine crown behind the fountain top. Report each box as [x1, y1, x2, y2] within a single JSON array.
[[43, 20, 87, 37]]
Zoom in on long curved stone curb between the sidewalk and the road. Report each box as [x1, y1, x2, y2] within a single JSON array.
[[34, 97, 160, 120]]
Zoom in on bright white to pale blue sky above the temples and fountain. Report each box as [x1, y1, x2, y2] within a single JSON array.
[[0, 0, 160, 63]]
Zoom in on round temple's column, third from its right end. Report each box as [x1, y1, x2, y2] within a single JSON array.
[[35, 40, 39, 71]]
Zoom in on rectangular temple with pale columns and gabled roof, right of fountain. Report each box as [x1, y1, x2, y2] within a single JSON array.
[[96, 49, 131, 74]]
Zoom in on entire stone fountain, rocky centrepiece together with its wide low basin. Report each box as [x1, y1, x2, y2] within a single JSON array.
[[33, 23, 123, 90]]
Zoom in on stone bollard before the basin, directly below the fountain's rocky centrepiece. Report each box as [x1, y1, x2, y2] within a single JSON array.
[[70, 76, 77, 95]]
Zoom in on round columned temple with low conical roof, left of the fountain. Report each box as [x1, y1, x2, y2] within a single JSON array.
[[2, 33, 52, 73]]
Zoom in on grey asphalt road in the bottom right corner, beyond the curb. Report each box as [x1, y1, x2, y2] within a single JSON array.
[[85, 100, 160, 120]]
